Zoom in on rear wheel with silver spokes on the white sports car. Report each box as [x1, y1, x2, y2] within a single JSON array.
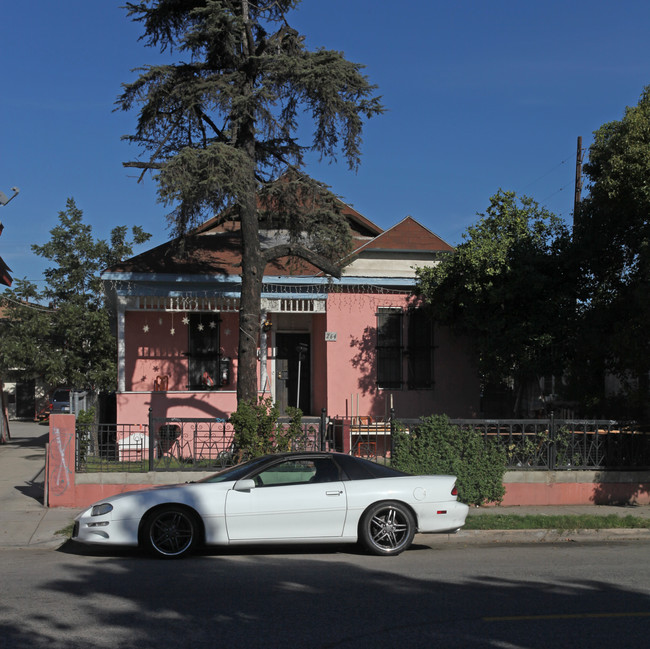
[[359, 501, 415, 556]]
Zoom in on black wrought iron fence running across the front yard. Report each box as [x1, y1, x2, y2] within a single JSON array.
[[76, 415, 650, 472]]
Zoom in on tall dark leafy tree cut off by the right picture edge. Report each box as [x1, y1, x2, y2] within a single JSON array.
[[574, 86, 650, 406]]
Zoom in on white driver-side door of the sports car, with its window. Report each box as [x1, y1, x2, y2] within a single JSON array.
[[226, 458, 347, 541]]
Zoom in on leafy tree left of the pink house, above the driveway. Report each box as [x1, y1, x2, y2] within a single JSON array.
[[0, 198, 150, 390]]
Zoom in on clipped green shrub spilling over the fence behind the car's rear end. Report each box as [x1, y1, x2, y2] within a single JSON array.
[[391, 415, 506, 505]]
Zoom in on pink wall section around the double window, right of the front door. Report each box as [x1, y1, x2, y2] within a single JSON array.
[[327, 293, 480, 418]]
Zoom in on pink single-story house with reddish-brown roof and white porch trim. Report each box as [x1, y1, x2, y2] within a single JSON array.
[[102, 189, 480, 424]]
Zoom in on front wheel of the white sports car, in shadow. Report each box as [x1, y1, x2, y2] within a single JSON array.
[[140, 505, 201, 559]]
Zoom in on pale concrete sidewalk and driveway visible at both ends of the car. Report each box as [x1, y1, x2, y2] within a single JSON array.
[[0, 421, 650, 548]]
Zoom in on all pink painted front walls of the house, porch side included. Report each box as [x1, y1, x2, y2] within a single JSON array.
[[118, 292, 480, 424]]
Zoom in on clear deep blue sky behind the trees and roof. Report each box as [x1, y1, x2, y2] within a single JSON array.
[[0, 0, 650, 287]]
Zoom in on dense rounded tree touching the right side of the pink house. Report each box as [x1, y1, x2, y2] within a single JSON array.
[[416, 190, 575, 410]]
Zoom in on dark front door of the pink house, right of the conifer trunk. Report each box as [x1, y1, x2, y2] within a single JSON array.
[[275, 333, 311, 415]]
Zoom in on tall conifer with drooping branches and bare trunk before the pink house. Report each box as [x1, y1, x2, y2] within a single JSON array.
[[118, 0, 383, 402]]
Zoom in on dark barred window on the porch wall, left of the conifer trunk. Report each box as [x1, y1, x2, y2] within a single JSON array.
[[188, 313, 220, 390]]
